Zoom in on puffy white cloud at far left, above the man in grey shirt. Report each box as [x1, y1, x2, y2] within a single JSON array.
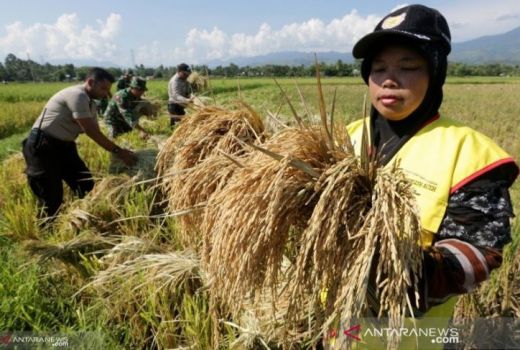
[[0, 13, 122, 60]]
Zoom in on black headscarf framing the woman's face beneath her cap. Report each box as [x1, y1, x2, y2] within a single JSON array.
[[361, 41, 448, 165]]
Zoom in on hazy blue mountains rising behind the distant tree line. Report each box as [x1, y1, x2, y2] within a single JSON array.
[[205, 27, 520, 68]]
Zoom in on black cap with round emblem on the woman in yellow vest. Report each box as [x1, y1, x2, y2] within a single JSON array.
[[352, 5, 451, 58]]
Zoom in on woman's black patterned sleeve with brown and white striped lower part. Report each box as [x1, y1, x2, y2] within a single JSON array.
[[419, 174, 514, 310]]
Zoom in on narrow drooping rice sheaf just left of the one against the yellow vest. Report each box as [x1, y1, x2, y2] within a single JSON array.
[[292, 156, 371, 320]]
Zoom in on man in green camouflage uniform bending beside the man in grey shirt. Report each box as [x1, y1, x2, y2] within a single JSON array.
[[105, 77, 148, 138]]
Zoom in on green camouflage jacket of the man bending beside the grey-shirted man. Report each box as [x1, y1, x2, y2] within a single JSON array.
[[104, 88, 142, 128]]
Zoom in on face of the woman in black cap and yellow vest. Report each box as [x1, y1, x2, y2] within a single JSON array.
[[368, 45, 429, 121]]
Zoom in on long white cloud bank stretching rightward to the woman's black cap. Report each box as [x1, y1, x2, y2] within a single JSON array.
[[136, 10, 380, 64]]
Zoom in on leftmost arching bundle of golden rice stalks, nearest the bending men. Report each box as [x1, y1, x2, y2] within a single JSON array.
[[157, 106, 263, 248]]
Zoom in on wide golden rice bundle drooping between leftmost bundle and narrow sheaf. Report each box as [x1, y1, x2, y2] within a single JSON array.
[[203, 128, 329, 310]]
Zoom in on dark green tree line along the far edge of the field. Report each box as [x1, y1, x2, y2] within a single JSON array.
[[0, 54, 520, 82]]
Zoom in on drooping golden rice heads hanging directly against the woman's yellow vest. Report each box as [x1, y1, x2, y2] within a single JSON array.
[[304, 165, 422, 349]]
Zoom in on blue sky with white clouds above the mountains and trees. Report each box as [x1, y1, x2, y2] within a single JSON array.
[[0, 0, 520, 67]]
